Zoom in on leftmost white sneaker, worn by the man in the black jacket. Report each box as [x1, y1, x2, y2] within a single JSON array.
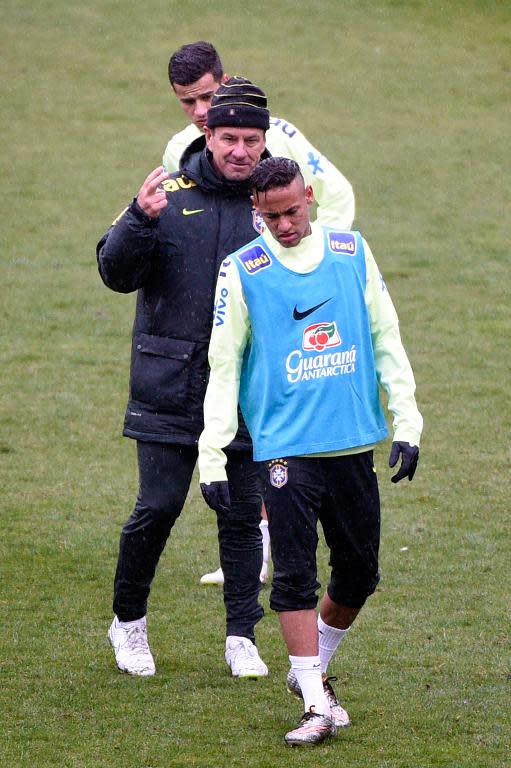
[[108, 616, 156, 677]]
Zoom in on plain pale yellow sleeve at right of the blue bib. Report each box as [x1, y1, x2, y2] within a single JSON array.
[[364, 240, 423, 445]]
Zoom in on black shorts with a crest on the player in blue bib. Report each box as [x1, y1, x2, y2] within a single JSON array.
[[262, 451, 380, 611]]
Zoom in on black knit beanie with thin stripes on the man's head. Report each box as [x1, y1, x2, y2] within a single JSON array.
[[208, 77, 270, 131]]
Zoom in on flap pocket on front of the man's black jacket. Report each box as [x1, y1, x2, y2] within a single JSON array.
[[131, 333, 196, 412]]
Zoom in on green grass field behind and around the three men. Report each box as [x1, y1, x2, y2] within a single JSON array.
[[0, 0, 511, 768]]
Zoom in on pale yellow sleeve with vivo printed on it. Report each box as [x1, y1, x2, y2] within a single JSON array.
[[199, 257, 250, 483]]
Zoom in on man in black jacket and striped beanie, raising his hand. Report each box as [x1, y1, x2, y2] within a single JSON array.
[[97, 78, 269, 678]]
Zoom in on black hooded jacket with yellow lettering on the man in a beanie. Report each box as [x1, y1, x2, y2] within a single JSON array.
[[97, 145, 272, 449]]
